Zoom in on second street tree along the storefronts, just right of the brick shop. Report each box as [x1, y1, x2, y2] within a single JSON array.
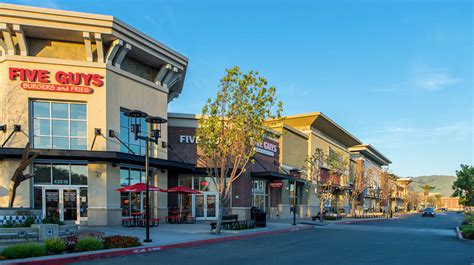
[[305, 148, 350, 222]]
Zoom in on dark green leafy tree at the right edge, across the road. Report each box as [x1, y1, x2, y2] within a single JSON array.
[[453, 165, 474, 208]]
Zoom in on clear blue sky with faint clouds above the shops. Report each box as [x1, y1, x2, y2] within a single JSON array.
[[7, 0, 474, 177]]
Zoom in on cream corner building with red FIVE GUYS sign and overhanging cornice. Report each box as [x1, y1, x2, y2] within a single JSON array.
[[0, 4, 194, 225]]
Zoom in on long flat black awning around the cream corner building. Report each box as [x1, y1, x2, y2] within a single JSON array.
[[0, 148, 194, 170]]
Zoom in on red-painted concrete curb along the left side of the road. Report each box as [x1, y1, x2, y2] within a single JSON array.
[[2, 226, 314, 265]]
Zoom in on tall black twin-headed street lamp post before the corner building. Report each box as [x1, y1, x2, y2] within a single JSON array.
[[125, 110, 167, 242]]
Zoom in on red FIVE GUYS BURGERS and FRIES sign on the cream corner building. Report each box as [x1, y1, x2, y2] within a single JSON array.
[[8, 67, 104, 94]]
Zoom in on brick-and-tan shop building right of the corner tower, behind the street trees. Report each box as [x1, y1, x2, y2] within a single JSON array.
[[168, 112, 390, 220]]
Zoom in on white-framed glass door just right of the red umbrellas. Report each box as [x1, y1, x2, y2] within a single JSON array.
[[193, 192, 219, 220]]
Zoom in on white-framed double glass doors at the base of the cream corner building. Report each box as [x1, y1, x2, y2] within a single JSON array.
[[43, 187, 80, 222]]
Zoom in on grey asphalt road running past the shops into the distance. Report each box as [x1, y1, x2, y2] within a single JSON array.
[[78, 213, 474, 265]]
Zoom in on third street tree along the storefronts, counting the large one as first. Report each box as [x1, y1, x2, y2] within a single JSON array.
[[349, 160, 377, 216]]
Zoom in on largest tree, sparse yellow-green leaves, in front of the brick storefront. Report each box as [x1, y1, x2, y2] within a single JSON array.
[[196, 67, 282, 233]]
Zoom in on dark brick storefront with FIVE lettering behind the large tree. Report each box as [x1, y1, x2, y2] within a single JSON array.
[[168, 113, 304, 220]]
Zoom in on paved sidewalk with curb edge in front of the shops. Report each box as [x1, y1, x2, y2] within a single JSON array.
[[0, 223, 314, 265]]
